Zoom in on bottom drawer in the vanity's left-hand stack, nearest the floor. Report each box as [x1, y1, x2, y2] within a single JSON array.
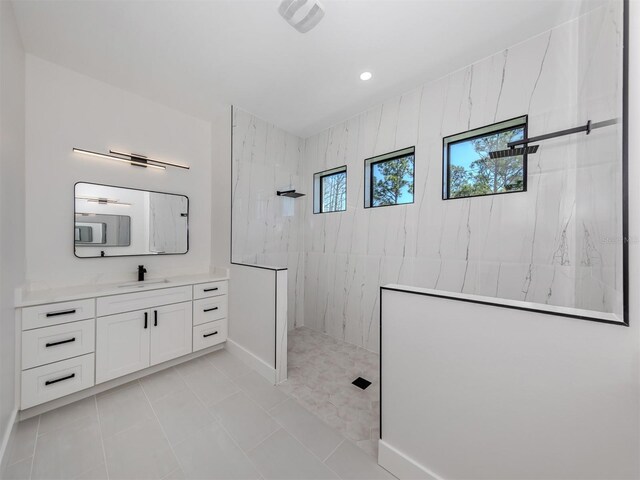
[[20, 353, 94, 410]]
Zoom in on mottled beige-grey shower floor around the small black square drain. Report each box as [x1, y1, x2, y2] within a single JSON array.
[[279, 327, 380, 457]]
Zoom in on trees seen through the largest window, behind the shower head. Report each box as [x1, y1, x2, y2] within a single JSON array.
[[449, 128, 524, 198]]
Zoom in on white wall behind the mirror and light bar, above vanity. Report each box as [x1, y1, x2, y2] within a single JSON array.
[[26, 55, 212, 289]]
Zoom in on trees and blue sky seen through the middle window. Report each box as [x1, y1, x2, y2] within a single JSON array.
[[371, 155, 414, 207]]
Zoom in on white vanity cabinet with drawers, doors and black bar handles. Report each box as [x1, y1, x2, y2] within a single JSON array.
[[19, 276, 228, 410]]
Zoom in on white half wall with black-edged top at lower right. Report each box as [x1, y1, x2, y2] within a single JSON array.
[[380, 286, 640, 480]]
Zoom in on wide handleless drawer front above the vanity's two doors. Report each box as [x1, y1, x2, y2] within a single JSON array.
[[98, 286, 192, 317]]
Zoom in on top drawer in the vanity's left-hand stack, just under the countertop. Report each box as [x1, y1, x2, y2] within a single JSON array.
[[22, 298, 96, 330]]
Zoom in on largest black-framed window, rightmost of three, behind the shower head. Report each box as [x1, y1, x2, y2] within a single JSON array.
[[442, 115, 527, 200]]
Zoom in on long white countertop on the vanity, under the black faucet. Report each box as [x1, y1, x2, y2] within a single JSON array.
[[15, 272, 229, 308]]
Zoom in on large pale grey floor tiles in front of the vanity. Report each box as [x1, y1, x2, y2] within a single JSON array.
[[2, 348, 394, 480]]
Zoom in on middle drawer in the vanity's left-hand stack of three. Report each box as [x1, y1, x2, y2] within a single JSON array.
[[22, 319, 95, 370]]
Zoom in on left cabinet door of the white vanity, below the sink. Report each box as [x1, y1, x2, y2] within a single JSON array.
[[96, 310, 152, 383]]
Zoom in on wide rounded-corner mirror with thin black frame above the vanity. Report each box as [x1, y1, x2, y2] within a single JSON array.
[[74, 183, 189, 258]]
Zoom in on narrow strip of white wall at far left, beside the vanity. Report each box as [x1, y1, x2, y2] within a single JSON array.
[[0, 2, 25, 464]]
